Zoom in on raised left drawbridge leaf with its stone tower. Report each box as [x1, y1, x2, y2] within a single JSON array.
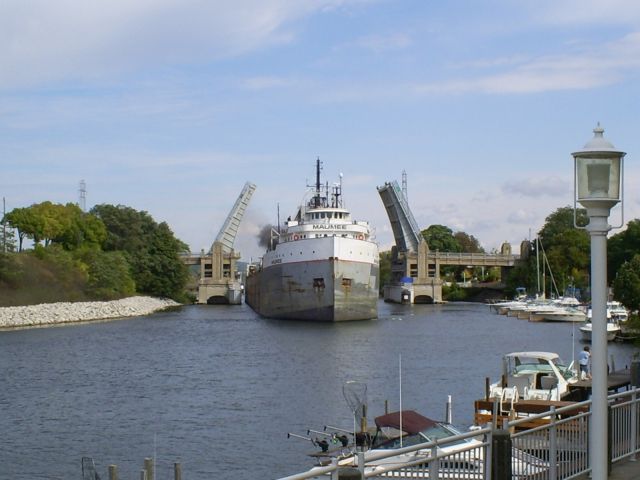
[[185, 182, 256, 305]]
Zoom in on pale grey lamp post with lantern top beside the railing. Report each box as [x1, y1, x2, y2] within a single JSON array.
[[572, 124, 625, 480]]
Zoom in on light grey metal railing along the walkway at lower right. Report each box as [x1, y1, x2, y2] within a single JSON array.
[[281, 388, 640, 480]]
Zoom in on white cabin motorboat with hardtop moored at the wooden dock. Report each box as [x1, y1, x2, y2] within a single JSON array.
[[489, 351, 578, 401]]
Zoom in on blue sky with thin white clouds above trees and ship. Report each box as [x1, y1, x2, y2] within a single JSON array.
[[0, 0, 640, 260]]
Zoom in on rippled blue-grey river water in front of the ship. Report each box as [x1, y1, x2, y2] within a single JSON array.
[[0, 302, 634, 480]]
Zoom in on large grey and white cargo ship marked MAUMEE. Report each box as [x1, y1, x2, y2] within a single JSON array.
[[245, 159, 379, 322]]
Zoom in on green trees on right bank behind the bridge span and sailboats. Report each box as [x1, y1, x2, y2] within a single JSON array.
[[380, 206, 640, 311]]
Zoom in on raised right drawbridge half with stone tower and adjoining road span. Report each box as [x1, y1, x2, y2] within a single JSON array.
[[378, 180, 519, 303]]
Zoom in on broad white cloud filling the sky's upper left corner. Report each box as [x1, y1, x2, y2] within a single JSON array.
[[0, 0, 357, 88]]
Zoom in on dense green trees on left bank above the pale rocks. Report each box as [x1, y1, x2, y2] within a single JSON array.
[[0, 201, 188, 301]]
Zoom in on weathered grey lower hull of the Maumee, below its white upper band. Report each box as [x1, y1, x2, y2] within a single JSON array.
[[245, 238, 379, 322]]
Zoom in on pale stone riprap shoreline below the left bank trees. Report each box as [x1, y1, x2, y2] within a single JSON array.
[[0, 296, 181, 330]]
